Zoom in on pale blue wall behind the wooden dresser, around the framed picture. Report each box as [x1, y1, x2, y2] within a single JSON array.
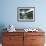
[[0, 0, 46, 31]]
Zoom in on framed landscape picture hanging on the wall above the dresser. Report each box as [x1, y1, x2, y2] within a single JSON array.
[[17, 7, 35, 22]]
